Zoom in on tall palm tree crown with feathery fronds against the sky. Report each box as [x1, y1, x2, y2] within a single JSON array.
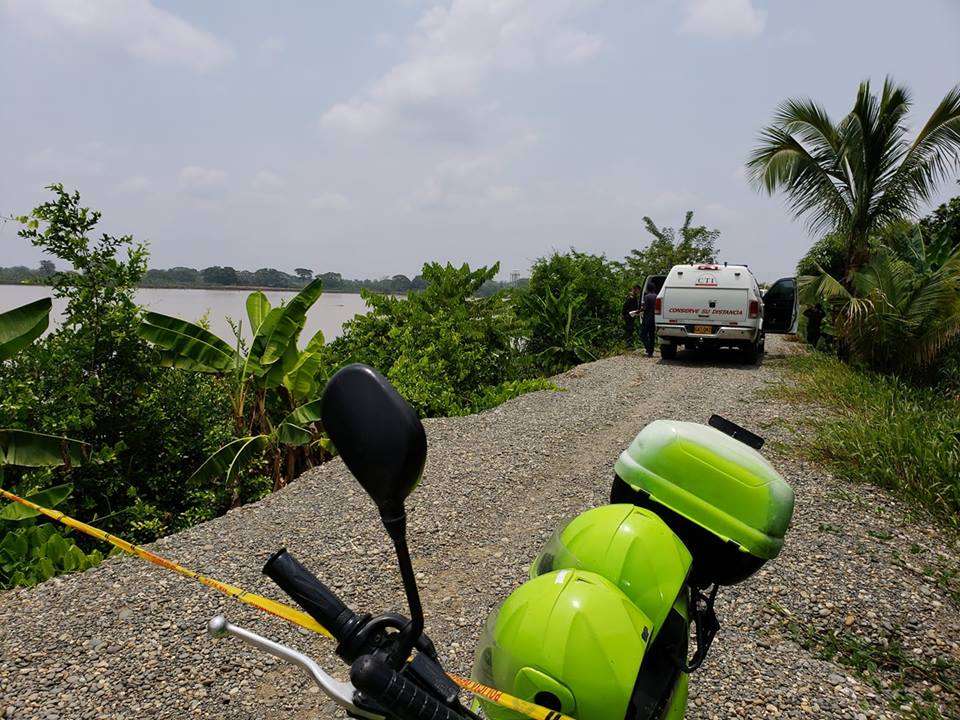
[[747, 78, 960, 288]]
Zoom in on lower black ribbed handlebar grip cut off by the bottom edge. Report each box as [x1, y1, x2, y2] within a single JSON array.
[[350, 655, 464, 720]]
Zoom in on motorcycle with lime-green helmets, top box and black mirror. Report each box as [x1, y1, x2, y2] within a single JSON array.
[[218, 365, 794, 720]]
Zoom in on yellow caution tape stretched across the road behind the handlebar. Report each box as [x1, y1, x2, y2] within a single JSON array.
[[0, 488, 573, 720]]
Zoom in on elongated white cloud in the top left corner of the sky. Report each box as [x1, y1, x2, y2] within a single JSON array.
[[2, 0, 233, 72]]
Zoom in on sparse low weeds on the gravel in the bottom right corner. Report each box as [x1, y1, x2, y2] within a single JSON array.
[[770, 602, 960, 720]]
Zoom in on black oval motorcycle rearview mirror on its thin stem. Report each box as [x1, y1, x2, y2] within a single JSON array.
[[320, 363, 427, 670]]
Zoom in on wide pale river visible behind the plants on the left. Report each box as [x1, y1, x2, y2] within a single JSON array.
[[0, 285, 367, 344]]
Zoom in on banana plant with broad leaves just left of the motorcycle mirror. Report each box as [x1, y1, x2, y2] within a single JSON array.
[[140, 280, 329, 504]]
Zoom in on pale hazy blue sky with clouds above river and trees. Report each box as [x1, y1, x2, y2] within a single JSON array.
[[0, 0, 960, 280]]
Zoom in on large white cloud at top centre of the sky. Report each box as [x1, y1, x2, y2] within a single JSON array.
[[321, 0, 603, 139]]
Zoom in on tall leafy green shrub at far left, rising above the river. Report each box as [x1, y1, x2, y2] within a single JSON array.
[[0, 185, 238, 542]]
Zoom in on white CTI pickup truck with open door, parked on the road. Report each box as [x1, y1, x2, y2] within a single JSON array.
[[654, 263, 797, 363]]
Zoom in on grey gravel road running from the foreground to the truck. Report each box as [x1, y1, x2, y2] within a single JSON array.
[[0, 339, 960, 720]]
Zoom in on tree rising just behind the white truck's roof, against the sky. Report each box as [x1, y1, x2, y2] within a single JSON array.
[[624, 210, 720, 285]]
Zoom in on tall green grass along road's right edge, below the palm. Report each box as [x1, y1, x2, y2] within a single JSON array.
[[774, 353, 960, 527]]
